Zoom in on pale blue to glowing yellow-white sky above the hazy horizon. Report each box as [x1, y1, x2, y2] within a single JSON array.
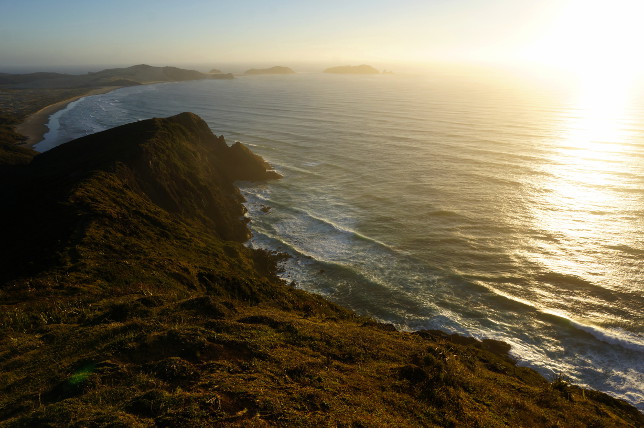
[[0, 0, 644, 75]]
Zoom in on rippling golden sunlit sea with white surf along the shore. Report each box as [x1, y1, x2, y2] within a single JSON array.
[[36, 73, 644, 410]]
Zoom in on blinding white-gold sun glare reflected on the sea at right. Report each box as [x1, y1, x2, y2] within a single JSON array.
[[523, 76, 644, 321]]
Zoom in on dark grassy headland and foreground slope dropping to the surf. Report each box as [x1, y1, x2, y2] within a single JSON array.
[[0, 113, 644, 427]]
